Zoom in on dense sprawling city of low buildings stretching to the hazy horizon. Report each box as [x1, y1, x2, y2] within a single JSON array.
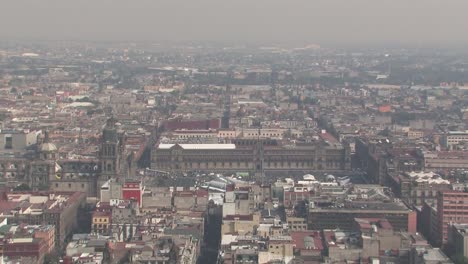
[[0, 41, 468, 264]]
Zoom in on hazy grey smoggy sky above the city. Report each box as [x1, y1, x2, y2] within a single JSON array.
[[0, 0, 468, 45]]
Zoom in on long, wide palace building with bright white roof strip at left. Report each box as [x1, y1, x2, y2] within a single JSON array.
[[151, 139, 350, 173]]
